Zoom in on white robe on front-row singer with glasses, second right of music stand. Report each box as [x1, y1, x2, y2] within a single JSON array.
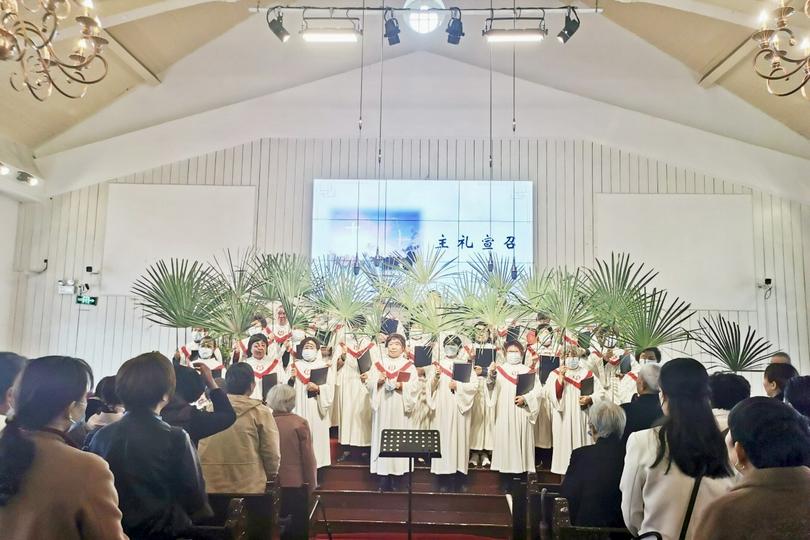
[[482, 364, 541, 473]]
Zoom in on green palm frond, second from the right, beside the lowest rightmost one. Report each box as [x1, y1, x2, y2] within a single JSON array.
[[618, 288, 694, 351]]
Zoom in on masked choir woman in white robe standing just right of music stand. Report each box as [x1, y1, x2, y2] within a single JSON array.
[[426, 336, 478, 491]]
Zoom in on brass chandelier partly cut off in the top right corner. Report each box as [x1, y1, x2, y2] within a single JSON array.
[[751, 0, 810, 99]]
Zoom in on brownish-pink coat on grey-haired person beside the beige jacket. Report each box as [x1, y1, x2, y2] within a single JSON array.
[[273, 412, 318, 492]]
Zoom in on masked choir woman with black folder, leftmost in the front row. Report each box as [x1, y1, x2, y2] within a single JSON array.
[[290, 337, 335, 469]]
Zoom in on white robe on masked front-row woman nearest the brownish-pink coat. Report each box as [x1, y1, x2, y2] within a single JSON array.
[[290, 353, 335, 469]]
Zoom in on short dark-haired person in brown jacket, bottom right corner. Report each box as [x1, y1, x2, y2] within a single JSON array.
[[693, 397, 810, 540]]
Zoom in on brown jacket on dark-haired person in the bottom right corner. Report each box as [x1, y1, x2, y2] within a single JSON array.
[[693, 467, 810, 540]]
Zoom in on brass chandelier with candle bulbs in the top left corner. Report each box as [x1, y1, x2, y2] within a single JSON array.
[[0, 0, 108, 101]]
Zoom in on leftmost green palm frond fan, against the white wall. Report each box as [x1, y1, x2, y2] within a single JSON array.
[[132, 259, 212, 328]]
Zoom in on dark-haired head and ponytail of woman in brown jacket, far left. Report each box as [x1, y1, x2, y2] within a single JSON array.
[[0, 356, 93, 507]]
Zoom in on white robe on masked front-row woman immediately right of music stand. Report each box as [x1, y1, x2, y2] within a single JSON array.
[[426, 358, 478, 474]]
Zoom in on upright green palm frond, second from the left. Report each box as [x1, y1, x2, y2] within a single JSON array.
[[205, 251, 263, 338]]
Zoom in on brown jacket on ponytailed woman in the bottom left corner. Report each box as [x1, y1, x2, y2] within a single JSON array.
[[0, 432, 127, 540]]
